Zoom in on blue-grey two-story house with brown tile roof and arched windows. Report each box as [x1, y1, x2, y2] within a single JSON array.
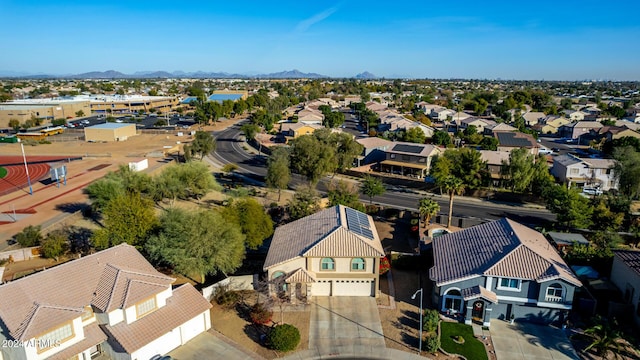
[[429, 218, 581, 326]]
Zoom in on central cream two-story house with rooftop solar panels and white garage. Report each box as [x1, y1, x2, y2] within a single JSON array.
[[264, 205, 385, 302]]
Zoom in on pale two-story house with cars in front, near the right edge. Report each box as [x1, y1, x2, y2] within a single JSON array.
[[550, 154, 618, 191]]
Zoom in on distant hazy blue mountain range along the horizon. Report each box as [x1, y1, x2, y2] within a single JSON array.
[[0, 69, 378, 79]]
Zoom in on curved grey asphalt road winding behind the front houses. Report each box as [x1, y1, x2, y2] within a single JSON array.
[[212, 122, 556, 225]]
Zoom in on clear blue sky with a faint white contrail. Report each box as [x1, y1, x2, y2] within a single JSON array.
[[0, 0, 640, 80]]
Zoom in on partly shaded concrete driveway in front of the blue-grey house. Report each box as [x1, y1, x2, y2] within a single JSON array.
[[490, 320, 579, 360]]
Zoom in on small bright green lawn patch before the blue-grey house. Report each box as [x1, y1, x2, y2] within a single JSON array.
[[440, 321, 488, 360]]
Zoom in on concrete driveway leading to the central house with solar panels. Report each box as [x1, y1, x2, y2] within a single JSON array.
[[309, 296, 386, 357]]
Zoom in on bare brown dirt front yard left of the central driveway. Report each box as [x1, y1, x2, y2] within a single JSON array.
[[211, 292, 311, 359]]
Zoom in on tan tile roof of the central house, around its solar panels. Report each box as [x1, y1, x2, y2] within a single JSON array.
[[264, 205, 384, 269]]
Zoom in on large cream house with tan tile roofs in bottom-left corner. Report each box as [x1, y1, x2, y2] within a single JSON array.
[[0, 244, 211, 360]]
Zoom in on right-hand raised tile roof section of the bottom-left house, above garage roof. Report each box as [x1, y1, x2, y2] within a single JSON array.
[[91, 264, 175, 312]]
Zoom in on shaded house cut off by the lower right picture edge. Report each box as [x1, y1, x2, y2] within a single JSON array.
[[611, 250, 640, 326]]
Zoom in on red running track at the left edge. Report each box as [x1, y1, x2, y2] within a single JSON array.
[[0, 156, 78, 195]]
